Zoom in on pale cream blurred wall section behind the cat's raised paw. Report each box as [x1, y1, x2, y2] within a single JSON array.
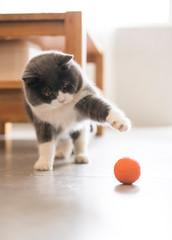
[[109, 27, 172, 126]]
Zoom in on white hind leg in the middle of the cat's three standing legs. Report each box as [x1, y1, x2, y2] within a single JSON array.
[[56, 137, 73, 158]]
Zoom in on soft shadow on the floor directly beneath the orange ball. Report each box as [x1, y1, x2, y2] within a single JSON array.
[[114, 184, 140, 194]]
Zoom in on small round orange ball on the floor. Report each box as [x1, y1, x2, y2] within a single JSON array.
[[114, 158, 140, 184]]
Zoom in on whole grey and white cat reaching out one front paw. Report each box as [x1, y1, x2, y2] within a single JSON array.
[[22, 51, 131, 170]]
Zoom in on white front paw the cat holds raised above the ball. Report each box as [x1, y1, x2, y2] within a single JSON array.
[[106, 110, 131, 132]]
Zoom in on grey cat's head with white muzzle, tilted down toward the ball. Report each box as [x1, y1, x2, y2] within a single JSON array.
[[22, 51, 82, 110]]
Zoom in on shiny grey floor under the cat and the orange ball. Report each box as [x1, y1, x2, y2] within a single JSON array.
[[0, 127, 172, 240]]
